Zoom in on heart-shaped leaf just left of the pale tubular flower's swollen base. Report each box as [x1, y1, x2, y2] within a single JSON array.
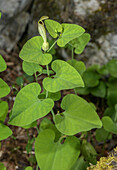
[[19, 36, 52, 65]]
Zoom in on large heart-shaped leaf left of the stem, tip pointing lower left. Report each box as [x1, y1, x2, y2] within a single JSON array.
[[9, 83, 54, 126]]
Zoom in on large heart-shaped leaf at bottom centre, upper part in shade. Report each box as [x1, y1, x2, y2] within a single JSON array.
[[35, 130, 80, 170]]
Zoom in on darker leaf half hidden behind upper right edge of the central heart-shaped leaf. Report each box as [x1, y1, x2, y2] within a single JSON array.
[[67, 59, 86, 75]]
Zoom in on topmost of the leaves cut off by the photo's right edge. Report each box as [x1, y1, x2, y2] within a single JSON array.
[[107, 59, 117, 78]]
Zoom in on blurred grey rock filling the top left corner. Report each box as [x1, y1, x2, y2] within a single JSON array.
[[0, 0, 32, 52]]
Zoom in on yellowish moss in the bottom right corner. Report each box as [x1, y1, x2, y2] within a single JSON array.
[[87, 147, 117, 170]]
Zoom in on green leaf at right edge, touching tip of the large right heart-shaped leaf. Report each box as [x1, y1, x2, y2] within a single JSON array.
[[102, 116, 117, 135]]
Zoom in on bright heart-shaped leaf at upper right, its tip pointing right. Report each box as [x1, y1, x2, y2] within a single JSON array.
[[57, 24, 85, 47]]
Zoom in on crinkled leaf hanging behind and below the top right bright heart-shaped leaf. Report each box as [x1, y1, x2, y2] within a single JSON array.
[[70, 33, 90, 54]]
